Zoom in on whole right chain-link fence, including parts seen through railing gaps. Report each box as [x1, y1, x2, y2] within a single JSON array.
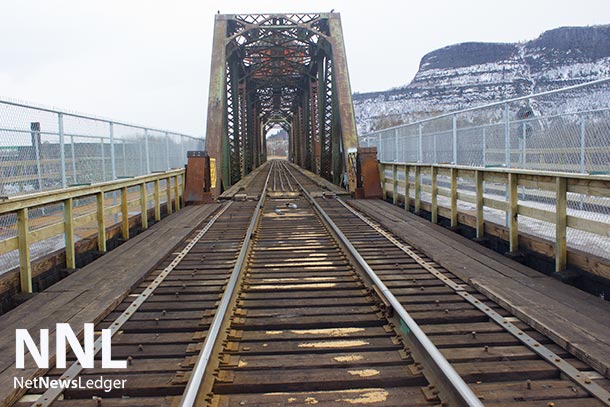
[[359, 78, 610, 268]]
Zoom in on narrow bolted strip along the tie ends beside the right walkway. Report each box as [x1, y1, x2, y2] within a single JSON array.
[[337, 198, 610, 407]]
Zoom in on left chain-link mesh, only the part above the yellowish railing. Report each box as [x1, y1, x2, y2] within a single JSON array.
[[0, 96, 204, 197]]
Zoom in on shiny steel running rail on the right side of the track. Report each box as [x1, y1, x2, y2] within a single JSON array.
[[286, 162, 483, 407]]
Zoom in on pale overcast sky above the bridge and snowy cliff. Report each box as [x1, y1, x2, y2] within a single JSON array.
[[0, 0, 610, 136]]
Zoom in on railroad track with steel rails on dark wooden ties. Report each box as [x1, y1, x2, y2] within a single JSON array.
[[17, 162, 608, 407]]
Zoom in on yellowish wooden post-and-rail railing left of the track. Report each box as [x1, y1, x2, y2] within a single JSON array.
[[0, 169, 185, 292]]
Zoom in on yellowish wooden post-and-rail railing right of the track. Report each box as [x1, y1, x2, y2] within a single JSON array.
[[379, 163, 610, 276]]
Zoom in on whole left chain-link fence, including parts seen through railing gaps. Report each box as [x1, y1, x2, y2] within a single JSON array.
[[0, 100, 204, 274]]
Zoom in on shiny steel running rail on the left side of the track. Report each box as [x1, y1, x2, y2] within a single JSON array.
[[179, 162, 274, 407]]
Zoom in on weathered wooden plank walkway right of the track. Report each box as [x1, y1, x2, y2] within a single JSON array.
[[349, 200, 610, 377]]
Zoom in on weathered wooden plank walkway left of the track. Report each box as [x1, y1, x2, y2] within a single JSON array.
[[0, 204, 219, 406]]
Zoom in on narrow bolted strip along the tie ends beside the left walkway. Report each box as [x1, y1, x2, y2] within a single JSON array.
[[31, 202, 232, 407]]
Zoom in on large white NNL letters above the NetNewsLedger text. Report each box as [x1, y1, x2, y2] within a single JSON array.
[[15, 324, 127, 369]]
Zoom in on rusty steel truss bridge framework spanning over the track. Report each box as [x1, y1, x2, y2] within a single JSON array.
[[206, 13, 358, 195]]
